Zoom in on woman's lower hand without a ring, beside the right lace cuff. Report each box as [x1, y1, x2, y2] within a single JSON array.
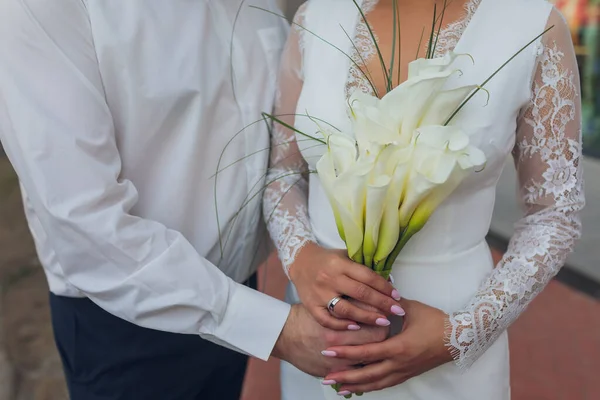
[[323, 299, 452, 395]]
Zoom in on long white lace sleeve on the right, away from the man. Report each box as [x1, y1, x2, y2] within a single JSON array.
[[447, 10, 584, 368]]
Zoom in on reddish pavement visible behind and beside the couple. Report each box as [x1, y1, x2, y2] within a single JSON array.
[[242, 248, 600, 400]]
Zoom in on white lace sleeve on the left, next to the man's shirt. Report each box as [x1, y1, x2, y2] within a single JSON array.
[[263, 6, 315, 280]]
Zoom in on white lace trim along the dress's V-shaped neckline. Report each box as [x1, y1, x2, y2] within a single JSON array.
[[345, 0, 485, 97]]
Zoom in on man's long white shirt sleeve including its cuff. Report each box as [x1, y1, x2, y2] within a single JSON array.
[[0, 0, 289, 359]]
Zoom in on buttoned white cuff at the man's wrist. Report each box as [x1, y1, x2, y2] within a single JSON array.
[[206, 284, 290, 361]]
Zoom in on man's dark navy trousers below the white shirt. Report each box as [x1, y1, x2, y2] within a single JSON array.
[[50, 276, 255, 400]]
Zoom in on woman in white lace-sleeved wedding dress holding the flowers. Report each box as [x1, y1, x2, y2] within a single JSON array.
[[264, 0, 584, 400]]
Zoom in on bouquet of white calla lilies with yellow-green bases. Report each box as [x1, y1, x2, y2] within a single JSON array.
[[317, 53, 486, 279]]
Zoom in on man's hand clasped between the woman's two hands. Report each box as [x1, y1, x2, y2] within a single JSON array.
[[273, 304, 389, 377]]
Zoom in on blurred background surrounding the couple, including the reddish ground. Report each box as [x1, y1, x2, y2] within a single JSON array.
[[0, 0, 600, 400]]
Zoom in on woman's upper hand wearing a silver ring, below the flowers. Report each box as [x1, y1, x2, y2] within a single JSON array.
[[289, 243, 404, 330]]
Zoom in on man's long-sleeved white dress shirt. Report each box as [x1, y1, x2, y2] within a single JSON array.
[[0, 0, 289, 359]]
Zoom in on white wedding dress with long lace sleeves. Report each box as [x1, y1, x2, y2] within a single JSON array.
[[264, 0, 584, 400]]
